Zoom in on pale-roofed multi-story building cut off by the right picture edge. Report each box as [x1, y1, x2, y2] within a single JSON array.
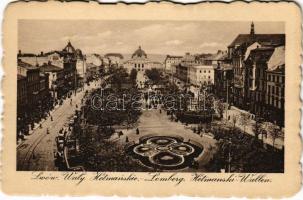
[[265, 46, 285, 126]]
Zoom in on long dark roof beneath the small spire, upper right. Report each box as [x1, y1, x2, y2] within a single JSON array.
[[228, 34, 285, 47]]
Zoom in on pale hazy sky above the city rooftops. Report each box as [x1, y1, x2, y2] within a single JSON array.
[[18, 20, 284, 55]]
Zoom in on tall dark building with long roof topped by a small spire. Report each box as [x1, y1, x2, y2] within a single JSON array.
[[228, 23, 285, 110]]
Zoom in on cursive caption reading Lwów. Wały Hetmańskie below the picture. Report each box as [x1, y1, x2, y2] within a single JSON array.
[[31, 172, 272, 186]]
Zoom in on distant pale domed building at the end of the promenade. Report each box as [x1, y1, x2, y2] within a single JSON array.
[[124, 46, 163, 72]]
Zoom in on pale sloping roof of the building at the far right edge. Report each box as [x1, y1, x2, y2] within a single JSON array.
[[268, 46, 285, 71]]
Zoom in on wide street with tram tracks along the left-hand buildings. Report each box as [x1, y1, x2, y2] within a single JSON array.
[[17, 80, 99, 171]]
